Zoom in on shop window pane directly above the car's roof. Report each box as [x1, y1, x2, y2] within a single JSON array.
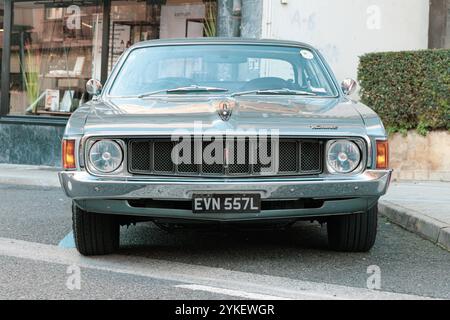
[[108, 0, 217, 71]]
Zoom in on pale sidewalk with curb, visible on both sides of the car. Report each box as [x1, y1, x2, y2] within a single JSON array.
[[0, 164, 450, 251]]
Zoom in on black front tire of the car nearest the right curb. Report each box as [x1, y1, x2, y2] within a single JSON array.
[[327, 203, 378, 252]]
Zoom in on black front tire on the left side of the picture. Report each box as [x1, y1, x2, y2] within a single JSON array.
[[72, 203, 120, 256]]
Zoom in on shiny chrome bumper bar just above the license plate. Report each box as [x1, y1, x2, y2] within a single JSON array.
[[59, 170, 391, 200]]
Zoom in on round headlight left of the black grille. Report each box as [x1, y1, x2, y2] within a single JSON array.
[[89, 140, 123, 173]]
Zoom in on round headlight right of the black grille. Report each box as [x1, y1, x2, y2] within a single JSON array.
[[327, 140, 361, 173]]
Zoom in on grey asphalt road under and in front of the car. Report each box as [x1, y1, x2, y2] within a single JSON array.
[[0, 185, 450, 299]]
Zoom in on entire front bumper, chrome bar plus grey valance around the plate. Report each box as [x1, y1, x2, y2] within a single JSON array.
[[59, 170, 391, 221]]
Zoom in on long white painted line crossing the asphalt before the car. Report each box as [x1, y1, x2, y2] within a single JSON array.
[[0, 238, 434, 300]]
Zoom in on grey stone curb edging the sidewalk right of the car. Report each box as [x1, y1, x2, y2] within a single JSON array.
[[378, 200, 450, 251]]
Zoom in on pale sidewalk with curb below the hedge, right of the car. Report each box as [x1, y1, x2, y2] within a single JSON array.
[[378, 181, 450, 251]]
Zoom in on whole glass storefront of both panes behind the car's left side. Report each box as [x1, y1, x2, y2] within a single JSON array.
[[0, 0, 217, 117]]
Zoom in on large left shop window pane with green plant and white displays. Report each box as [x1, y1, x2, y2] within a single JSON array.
[[9, 2, 102, 116]]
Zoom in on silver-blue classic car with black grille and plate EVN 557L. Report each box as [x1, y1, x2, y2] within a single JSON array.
[[59, 38, 391, 255]]
